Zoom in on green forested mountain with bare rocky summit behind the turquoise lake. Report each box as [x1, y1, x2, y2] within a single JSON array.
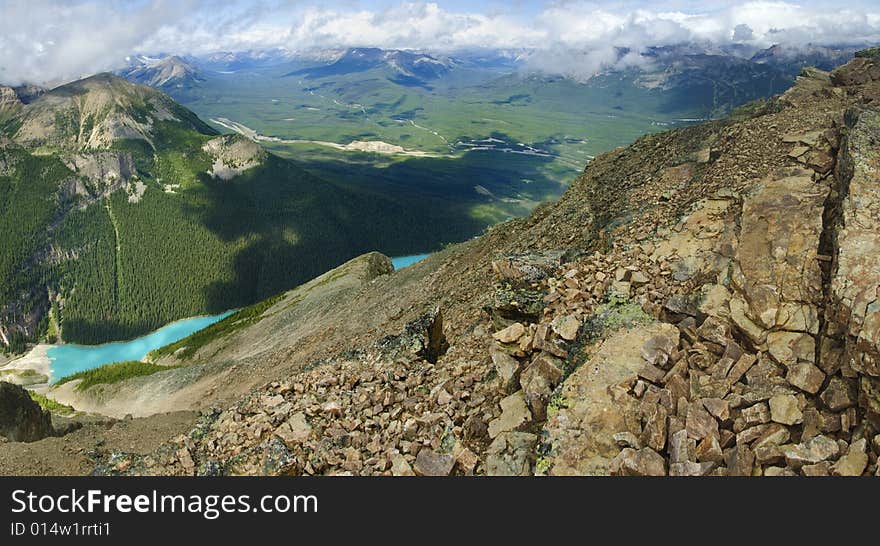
[[0, 75, 434, 344]]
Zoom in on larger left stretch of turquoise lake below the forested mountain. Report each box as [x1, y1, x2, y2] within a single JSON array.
[[47, 311, 234, 381]]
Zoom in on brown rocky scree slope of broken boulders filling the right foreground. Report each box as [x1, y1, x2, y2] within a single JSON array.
[[12, 51, 880, 476]]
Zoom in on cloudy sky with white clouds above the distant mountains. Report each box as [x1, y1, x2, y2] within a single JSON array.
[[0, 0, 880, 84]]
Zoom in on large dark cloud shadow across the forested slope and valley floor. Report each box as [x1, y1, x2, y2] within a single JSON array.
[[184, 143, 563, 313]]
